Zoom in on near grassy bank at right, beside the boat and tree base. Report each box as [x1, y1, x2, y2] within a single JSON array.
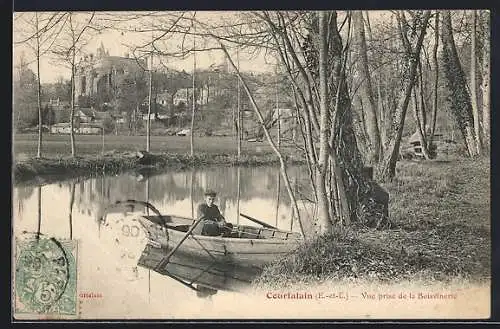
[[255, 158, 491, 288]]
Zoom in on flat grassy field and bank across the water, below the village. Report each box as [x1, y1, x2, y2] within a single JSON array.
[[13, 134, 297, 184]]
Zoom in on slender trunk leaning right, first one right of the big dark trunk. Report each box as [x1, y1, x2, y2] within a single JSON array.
[[379, 10, 430, 181]]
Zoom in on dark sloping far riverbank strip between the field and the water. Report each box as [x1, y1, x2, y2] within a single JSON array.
[[13, 152, 302, 185]]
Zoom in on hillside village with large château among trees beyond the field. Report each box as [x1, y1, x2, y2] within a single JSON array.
[[14, 44, 295, 138]]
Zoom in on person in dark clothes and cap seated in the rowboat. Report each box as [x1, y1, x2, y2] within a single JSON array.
[[193, 190, 233, 236]]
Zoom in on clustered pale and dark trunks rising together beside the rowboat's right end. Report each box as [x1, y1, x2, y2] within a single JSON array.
[[264, 11, 380, 231]]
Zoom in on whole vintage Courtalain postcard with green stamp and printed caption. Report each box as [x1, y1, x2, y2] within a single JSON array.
[[11, 10, 491, 321]]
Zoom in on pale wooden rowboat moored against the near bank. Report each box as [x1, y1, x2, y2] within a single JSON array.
[[138, 215, 302, 267]]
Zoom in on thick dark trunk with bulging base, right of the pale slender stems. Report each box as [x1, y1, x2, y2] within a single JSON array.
[[330, 20, 389, 227]]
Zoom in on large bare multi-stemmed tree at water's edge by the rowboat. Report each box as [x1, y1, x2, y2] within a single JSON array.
[[257, 11, 387, 229]]
